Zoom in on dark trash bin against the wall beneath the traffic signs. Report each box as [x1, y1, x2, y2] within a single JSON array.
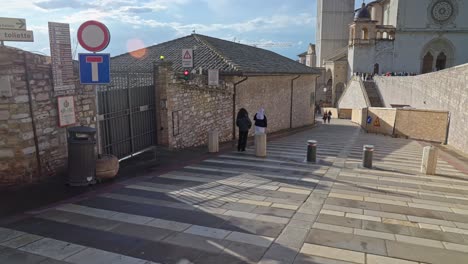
[[67, 126, 96, 186]]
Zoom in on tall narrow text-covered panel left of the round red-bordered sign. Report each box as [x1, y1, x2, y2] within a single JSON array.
[[49, 22, 75, 92]]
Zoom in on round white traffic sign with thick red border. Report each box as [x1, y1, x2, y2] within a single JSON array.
[[78, 20, 110, 52]]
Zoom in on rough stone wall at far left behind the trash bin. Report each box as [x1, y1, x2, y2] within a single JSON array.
[[0, 47, 95, 184]]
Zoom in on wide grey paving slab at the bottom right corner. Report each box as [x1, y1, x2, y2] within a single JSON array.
[[385, 241, 468, 264]]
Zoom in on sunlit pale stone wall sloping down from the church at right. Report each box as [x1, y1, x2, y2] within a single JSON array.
[[375, 64, 468, 153]]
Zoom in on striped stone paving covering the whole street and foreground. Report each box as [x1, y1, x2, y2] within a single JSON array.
[[0, 120, 468, 264]]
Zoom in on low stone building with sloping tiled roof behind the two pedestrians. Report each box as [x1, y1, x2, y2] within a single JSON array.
[[111, 34, 319, 148]]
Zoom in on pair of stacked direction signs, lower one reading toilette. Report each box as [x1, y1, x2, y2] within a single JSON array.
[[0, 17, 34, 42]]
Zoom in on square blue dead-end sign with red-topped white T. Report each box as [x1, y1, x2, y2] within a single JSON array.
[[78, 53, 110, 84]]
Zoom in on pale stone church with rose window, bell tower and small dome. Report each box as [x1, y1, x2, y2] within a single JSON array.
[[316, 0, 468, 104]]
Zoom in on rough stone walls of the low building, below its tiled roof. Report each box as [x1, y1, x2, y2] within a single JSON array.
[[155, 63, 317, 148]]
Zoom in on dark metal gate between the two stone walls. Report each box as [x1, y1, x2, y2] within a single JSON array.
[[98, 72, 156, 159]]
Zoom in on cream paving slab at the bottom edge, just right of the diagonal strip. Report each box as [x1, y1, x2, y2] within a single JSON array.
[[301, 244, 365, 264]]
